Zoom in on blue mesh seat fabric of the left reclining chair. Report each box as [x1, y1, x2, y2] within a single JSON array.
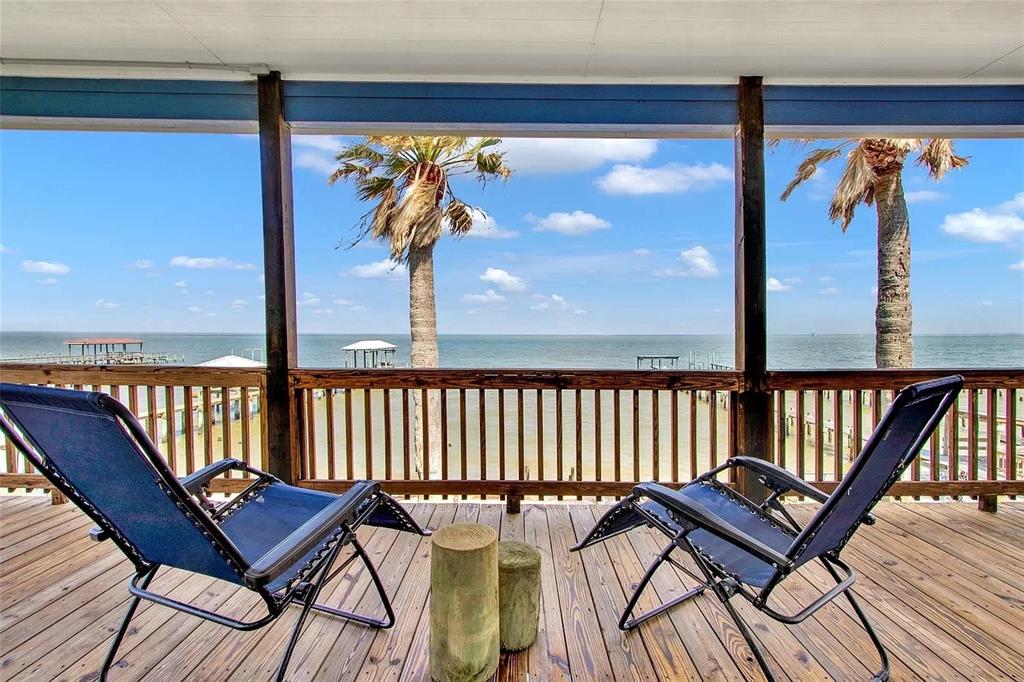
[[220, 483, 368, 592]]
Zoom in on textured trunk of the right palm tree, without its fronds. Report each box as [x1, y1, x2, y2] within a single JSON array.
[[874, 169, 913, 368]]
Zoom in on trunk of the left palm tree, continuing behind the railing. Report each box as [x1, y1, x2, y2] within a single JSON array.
[[409, 245, 441, 478]]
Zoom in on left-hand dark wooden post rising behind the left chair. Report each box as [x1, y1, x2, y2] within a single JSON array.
[[257, 72, 301, 483]]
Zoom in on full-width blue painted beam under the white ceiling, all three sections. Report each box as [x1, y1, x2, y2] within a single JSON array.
[[0, 77, 1024, 129]]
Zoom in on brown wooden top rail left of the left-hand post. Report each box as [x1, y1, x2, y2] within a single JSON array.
[[0, 363, 265, 387]]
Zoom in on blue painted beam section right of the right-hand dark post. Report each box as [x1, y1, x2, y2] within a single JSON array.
[[764, 85, 1024, 129]]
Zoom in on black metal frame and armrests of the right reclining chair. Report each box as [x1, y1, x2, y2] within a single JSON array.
[[570, 377, 963, 682]]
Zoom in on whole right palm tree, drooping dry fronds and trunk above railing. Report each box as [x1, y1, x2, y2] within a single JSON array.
[[780, 138, 968, 368]]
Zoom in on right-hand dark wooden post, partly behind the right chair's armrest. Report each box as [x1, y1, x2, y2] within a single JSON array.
[[731, 76, 771, 501]]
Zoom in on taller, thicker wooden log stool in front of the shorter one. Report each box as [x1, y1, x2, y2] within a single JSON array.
[[430, 523, 501, 682]]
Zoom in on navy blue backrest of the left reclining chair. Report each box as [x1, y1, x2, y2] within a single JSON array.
[[0, 384, 245, 583]]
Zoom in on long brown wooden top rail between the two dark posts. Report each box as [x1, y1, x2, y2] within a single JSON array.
[[291, 369, 742, 391]]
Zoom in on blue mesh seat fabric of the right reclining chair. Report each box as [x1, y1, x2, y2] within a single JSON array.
[[643, 483, 794, 587]]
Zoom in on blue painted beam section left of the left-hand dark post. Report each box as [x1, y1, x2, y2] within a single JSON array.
[[0, 76, 256, 122]]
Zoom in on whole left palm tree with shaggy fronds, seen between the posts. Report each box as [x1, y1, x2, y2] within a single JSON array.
[[328, 135, 512, 478]]
